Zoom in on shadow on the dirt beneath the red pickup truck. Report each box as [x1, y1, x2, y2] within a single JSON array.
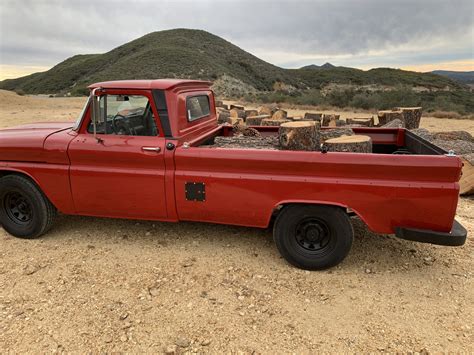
[[47, 216, 439, 272]]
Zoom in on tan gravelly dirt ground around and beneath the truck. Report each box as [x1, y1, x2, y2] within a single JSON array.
[[0, 92, 474, 354]]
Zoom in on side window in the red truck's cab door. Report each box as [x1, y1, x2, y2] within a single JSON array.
[[87, 95, 158, 136]]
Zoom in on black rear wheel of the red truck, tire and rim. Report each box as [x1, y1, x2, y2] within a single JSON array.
[[273, 205, 354, 270]]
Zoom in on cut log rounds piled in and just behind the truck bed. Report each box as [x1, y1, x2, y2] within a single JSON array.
[[213, 102, 373, 153]]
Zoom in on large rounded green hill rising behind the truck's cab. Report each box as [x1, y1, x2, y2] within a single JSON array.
[[0, 29, 296, 94]]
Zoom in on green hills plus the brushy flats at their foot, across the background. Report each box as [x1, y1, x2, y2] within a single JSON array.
[[0, 29, 474, 112]]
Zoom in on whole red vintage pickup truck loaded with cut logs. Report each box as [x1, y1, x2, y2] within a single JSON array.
[[0, 80, 467, 269]]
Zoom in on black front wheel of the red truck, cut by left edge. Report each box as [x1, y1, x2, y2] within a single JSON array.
[[0, 175, 56, 239]]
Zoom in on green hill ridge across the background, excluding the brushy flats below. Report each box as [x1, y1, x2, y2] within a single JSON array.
[[0, 29, 463, 95]]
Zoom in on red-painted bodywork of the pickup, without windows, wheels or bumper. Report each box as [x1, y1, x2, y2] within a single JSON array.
[[0, 80, 461, 233]]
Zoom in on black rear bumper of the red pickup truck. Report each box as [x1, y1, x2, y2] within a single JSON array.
[[395, 220, 467, 246]]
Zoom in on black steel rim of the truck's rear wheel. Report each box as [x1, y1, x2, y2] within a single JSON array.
[[295, 217, 333, 253]]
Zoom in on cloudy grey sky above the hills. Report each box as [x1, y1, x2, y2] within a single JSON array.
[[0, 0, 474, 80]]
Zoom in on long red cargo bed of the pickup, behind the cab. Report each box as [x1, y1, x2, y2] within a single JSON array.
[[175, 126, 461, 233]]
